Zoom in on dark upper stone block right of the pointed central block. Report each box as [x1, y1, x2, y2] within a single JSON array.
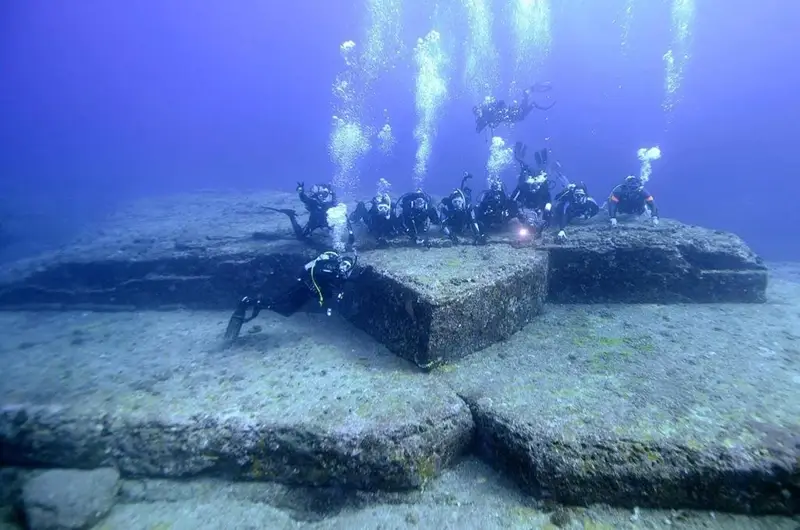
[[542, 219, 767, 303]]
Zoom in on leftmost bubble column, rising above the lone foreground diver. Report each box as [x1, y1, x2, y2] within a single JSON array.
[[328, 41, 370, 192]]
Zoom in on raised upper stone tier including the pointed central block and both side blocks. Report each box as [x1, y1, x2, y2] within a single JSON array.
[[0, 194, 767, 367]]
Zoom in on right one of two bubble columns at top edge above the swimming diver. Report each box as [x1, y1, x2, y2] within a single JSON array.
[[511, 0, 552, 92]]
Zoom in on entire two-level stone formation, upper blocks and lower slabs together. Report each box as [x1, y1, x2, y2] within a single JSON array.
[[0, 193, 788, 514]]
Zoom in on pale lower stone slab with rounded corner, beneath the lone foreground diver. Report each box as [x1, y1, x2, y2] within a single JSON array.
[[0, 311, 472, 489]]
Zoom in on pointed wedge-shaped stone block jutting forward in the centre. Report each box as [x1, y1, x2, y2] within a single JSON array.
[[348, 245, 547, 368]]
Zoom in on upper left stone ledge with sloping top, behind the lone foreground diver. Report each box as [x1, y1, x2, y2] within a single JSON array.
[[0, 193, 316, 309]]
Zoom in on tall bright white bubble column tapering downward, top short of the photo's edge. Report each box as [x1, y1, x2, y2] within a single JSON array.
[[414, 30, 447, 187]]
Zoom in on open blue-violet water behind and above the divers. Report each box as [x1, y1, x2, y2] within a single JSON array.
[[0, 0, 800, 260]]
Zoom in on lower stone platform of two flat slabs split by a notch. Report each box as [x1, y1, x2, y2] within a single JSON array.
[[0, 276, 800, 514]]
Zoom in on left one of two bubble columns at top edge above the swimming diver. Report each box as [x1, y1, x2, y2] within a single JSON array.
[[462, 0, 499, 100]]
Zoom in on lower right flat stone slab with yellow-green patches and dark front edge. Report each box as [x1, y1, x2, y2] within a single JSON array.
[[435, 274, 800, 514]]
